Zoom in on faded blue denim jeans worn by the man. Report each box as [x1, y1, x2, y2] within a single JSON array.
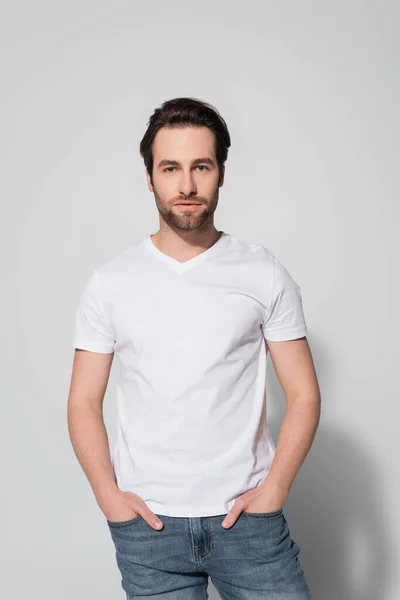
[[107, 508, 311, 600]]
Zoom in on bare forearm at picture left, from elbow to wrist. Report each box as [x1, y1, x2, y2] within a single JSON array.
[[68, 404, 118, 506]]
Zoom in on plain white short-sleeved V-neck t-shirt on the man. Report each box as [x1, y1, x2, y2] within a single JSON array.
[[73, 232, 307, 517]]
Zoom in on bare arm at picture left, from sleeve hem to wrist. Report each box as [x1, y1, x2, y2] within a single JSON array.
[[68, 349, 118, 510]]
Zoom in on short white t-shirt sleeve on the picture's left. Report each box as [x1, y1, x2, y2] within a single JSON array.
[[73, 271, 116, 354]]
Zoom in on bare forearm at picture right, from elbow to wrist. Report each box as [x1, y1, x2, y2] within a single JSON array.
[[259, 394, 321, 495]]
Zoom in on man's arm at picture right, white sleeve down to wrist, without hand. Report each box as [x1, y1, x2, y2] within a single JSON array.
[[257, 256, 321, 502]]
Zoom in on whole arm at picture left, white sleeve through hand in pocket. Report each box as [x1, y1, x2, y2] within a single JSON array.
[[68, 271, 162, 529]]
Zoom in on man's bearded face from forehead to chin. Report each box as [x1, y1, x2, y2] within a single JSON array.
[[146, 127, 224, 231]]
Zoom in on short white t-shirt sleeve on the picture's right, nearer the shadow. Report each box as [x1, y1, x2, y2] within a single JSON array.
[[262, 256, 308, 342]]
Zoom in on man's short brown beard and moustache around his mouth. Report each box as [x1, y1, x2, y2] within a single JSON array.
[[153, 183, 219, 231]]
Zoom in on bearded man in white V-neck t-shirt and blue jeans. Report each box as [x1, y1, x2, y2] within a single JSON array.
[[68, 98, 320, 600]]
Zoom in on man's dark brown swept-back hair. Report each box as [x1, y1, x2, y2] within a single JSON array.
[[139, 98, 231, 180]]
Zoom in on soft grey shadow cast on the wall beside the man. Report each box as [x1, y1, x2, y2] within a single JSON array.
[[267, 359, 390, 600]]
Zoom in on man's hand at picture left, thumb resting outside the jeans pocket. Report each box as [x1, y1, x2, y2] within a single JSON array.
[[100, 490, 163, 529]]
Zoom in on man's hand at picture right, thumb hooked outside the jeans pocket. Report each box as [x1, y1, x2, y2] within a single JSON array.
[[222, 480, 288, 527]]
